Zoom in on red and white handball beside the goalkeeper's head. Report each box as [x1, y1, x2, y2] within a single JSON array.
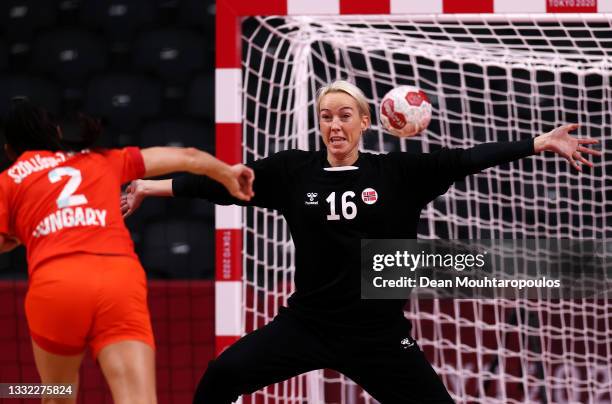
[[380, 86, 431, 137]]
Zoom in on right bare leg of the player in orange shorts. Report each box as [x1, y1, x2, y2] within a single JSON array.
[[98, 341, 157, 404]]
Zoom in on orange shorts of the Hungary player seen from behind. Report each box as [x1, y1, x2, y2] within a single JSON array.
[[25, 254, 155, 359]]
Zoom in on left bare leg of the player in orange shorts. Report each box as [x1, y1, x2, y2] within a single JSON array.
[[32, 340, 83, 404]]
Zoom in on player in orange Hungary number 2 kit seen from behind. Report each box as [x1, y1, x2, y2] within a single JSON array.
[[0, 99, 253, 404]]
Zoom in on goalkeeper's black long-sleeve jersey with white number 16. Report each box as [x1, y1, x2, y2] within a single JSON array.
[[173, 139, 534, 329]]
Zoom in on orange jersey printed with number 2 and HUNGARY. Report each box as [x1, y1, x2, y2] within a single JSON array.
[[0, 147, 145, 275]]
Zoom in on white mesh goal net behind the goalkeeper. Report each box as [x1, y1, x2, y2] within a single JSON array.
[[242, 15, 612, 403]]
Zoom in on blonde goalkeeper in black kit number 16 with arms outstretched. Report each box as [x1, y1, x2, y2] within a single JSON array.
[[122, 81, 600, 404]]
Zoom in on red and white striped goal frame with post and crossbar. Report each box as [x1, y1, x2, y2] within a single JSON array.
[[215, 0, 612, 355]]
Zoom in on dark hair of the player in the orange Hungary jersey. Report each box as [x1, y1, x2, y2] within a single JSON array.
[[3, 97, 102, 156]]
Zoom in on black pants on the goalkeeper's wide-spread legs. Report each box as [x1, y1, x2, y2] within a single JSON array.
[[193, 312, 453, 404]]
